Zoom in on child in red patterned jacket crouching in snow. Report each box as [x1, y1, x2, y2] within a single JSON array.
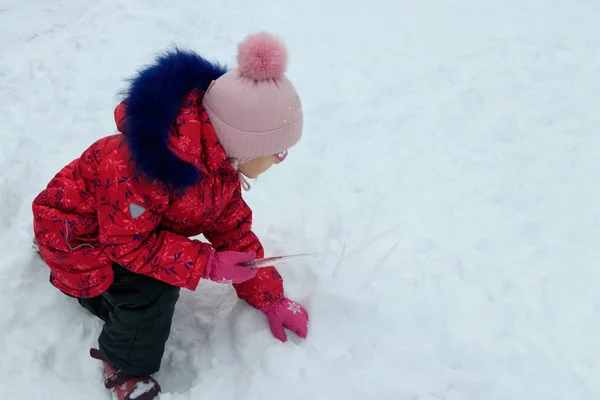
[[33, 34, 308, 400]]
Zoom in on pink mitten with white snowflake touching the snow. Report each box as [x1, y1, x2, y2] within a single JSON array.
[[261, 297, 308, 342]]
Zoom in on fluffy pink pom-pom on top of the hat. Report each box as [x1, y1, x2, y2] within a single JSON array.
[[237, 33, 287, 81]]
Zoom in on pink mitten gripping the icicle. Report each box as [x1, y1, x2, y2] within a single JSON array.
[[202, 251, 258, 284]]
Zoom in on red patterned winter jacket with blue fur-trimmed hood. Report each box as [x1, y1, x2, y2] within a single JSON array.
[[33, 50, 283, 308]]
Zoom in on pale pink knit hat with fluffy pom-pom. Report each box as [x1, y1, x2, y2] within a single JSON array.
[[203, 33, 303, 168]]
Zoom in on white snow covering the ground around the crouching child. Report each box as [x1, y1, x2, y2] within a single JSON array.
[[0, 0, 600, 400]]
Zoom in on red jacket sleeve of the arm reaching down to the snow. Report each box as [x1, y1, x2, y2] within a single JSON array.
[[204, 191, 284, 309]]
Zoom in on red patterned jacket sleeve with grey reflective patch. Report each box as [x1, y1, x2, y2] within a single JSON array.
[[96, 159, 212, 290]]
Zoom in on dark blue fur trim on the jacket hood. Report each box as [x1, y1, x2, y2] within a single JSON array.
[[124, 48, 227, 188]]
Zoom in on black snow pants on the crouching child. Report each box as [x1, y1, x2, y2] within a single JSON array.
[[78, 264, 179, 376]]
